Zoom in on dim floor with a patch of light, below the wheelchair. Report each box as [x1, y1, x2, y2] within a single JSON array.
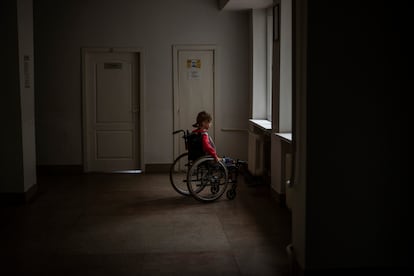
[[0, 171, 291, 276]]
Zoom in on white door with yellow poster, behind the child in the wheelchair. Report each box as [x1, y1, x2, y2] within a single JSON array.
[[174, 48, 215, 156]]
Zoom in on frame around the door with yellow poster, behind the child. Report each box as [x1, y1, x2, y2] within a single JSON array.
[[172, 44, 219, 158]]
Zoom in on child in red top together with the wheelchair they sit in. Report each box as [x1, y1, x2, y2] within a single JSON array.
[[170, 111, 244, 202]]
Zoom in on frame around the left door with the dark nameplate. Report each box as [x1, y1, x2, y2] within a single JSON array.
[[81, 47, 145, 172]]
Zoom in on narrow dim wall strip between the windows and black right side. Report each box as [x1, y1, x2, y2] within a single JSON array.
[[290, 0, 308, 269]]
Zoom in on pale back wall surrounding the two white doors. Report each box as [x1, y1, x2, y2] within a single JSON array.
[[34, 0, 249, 165]]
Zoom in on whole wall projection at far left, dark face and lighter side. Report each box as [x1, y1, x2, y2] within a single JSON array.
[[0, 0, 36, 194]]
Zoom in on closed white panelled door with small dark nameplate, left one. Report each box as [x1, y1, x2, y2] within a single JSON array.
[[84, 49, 140, 172]]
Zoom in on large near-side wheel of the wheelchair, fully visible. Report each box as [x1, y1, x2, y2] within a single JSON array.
[[187, 156, 228, 202]]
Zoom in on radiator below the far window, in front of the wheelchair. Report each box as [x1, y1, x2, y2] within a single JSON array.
[[247, 131, 264, 176]]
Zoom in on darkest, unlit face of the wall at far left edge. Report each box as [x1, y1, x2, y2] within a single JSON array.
[[0, 1, 23, 194]]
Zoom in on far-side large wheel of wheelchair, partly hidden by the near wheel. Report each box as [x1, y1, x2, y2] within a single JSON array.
[[170, 152, 190, 196]]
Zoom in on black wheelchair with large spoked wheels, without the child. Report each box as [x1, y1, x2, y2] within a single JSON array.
[[170, 130, 245, 202]]
